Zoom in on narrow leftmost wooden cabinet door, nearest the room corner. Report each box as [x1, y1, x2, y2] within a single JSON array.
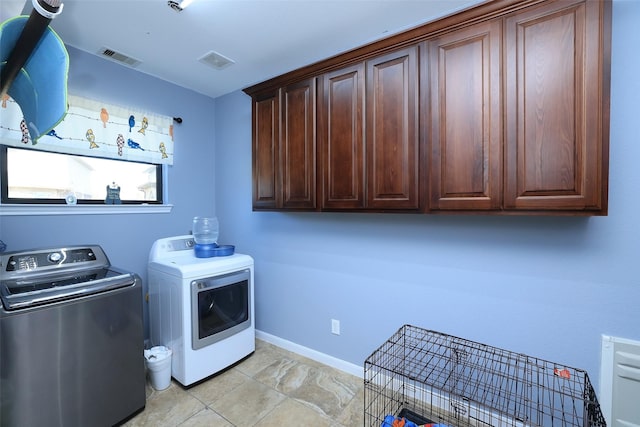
[[252, 91, 280, 210]]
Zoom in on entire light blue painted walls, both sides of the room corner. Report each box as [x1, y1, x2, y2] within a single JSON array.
[[0, 0, 640, 396]]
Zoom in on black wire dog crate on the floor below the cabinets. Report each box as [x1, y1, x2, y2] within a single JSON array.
[[364, 325, 606, 427]]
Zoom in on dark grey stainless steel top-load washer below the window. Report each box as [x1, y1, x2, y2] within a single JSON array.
[[0, 245, 145, 426]]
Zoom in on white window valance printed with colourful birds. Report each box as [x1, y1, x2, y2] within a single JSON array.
[[0, 95, 173, 165]]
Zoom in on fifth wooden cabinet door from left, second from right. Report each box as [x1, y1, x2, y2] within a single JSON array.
[[429, 21, 502, 210]]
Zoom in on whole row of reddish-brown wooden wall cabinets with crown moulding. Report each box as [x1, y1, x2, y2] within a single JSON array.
[[245, 0, 611, 215]]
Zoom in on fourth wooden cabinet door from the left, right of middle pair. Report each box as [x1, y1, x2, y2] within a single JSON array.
[[366, 46, 419, 209]]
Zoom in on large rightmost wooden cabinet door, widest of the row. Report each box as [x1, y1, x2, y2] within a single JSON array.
[[505, 1, 610, 213]]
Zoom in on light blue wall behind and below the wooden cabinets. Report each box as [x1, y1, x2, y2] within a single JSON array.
[[216, 1, 640, 392]]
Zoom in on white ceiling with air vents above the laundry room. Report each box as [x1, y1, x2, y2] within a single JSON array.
[[0, 0, 481, 98]]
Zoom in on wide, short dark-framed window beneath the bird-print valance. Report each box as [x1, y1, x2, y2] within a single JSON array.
[[0, 146, 162, 204]]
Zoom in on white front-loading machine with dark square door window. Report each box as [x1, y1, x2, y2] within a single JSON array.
[[148, 235, 255, 386]]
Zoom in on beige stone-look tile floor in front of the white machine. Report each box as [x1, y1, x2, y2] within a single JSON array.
[[124, 340, 364, 427]]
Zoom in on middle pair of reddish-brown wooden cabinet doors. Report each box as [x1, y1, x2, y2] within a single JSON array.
[[318, 46, 419, 210]]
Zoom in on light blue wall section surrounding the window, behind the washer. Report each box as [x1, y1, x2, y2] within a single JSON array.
[[0, 47, 215, 338]]
